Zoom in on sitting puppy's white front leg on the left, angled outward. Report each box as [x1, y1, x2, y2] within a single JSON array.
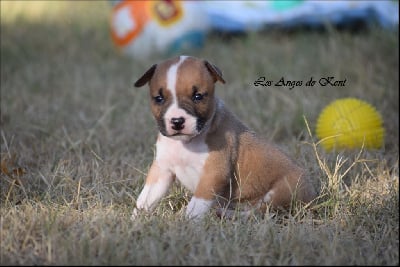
[[131, 161, 174, 220]]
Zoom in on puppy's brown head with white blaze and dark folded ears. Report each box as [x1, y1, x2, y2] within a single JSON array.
[[134, 56, 225, 141]]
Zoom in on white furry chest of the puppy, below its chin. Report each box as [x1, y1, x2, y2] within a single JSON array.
[[156, 136, 209, 192]]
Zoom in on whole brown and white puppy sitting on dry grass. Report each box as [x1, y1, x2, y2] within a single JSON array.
[[132, 56, 314, 221]]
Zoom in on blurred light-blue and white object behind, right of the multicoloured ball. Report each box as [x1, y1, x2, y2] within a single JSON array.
[[203, 0, 399, 32]]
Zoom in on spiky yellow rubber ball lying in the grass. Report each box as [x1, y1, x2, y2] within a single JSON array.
[[316, 98, 385, 151]]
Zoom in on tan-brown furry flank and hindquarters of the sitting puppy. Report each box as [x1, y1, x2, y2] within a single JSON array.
[[195, 99, 315, 207]]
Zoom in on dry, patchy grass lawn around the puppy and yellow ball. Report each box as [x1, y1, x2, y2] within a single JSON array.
[[0, 1, 399, 265]]
